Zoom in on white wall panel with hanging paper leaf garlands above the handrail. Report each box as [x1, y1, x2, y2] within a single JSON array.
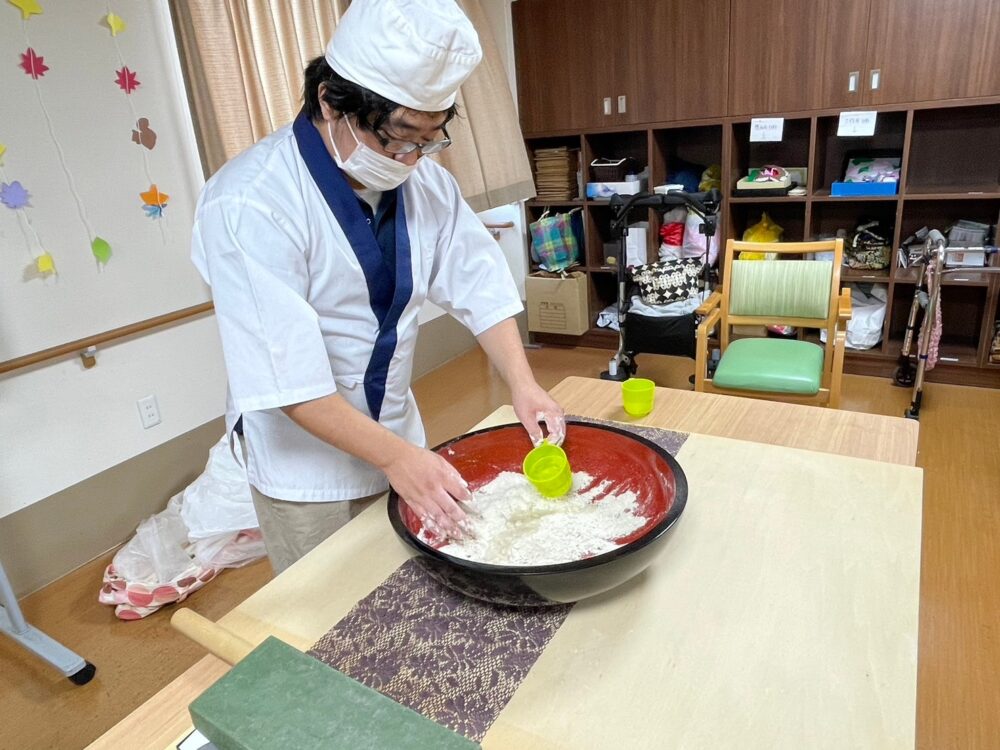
[[0, 0, 207, 362]]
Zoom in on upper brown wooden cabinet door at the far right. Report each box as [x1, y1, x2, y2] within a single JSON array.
[[864, 0, 1000, 104]]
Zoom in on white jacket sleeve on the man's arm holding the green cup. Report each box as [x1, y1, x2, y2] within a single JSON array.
[[427, 169, 524, 336]]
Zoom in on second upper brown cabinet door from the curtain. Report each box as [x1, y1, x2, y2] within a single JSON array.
[[627, 0, 740, 123]]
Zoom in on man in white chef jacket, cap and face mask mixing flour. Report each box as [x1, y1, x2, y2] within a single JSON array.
[[192, 0, 565, 572]]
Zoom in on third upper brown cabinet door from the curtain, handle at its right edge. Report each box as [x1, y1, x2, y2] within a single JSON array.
[[729, 0, 872, 115]]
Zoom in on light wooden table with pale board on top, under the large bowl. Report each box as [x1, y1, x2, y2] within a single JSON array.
[[91, 377, 922, 750]]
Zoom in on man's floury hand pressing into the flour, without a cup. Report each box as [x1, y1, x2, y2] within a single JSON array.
[[380, 443, 471, 537]]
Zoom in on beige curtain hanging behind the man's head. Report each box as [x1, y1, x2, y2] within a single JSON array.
[[170, 0, 535, 211]]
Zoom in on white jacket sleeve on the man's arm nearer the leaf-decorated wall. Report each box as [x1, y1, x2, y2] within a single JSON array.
[[192, 197, 337, 413]]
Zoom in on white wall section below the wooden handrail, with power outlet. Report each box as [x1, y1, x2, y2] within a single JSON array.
[[0, 315, 226, 523]]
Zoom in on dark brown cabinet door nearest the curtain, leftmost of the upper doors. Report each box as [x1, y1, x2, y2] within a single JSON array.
[[511, 0, 628, 134]]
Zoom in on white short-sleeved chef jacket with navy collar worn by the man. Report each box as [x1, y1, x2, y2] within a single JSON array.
[[192, 115, 522, 502]]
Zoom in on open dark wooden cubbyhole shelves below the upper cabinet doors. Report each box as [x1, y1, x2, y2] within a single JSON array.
[[526, 99, 1000, 387]]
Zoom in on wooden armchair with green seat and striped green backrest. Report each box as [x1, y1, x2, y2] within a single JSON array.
[[695, 239, 851, 408]]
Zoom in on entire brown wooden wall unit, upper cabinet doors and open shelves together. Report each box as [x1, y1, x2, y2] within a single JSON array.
[[512, 0, 1000, 387]]
